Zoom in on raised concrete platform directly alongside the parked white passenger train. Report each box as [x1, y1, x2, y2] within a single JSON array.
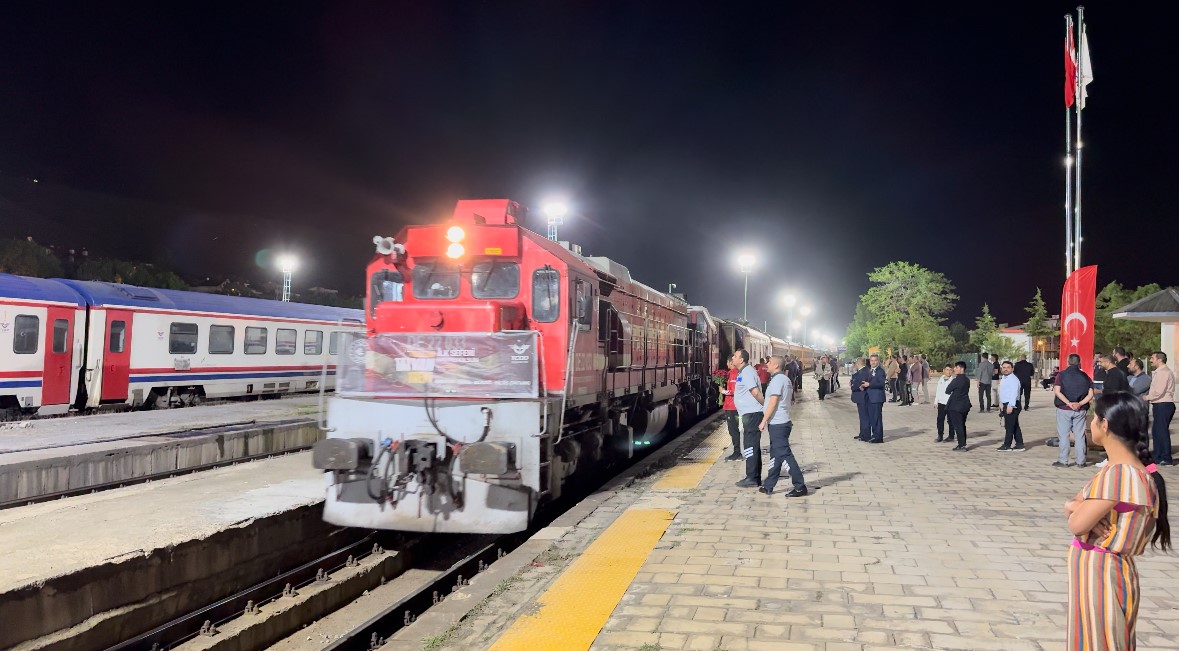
[[0, 395, 322, 506]]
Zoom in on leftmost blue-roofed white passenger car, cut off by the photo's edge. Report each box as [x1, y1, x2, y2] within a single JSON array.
[[0, 274, 86, 419]]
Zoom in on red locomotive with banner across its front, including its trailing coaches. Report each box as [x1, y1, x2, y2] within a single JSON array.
[[312, 199, 810, 533]]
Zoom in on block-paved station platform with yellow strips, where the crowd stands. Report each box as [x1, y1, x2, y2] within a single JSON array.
[[419, 382, 1179, 651]]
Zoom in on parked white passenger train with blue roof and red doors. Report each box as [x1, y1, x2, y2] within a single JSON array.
[[0, 274, 363, 417]]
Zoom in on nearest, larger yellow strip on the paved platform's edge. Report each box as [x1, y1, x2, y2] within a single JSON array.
[[490, 508, 676, 651]]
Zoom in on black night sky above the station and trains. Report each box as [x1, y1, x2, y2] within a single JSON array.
[[0, 0, 1179, 336]]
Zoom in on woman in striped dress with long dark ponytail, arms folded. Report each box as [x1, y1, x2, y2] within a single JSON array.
[[1065, 392, 1171, 651]]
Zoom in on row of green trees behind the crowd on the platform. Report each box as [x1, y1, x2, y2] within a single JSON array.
[[845, 261, 1161, 366]]
